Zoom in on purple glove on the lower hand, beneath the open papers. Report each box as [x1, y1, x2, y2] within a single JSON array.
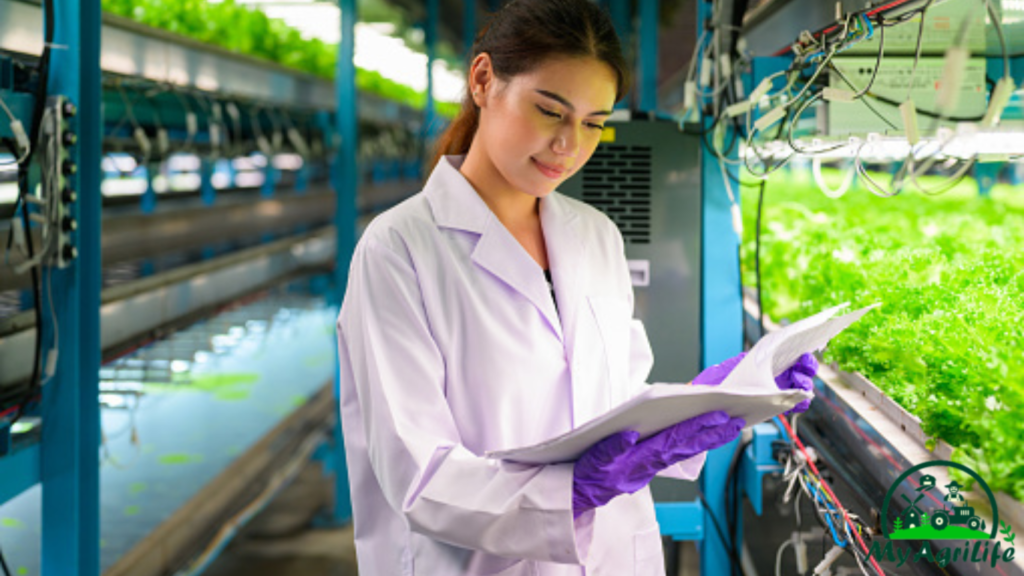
[[572, 410, 746, 518]]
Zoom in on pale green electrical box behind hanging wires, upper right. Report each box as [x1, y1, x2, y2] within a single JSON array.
[[818, 56, 988, 136]]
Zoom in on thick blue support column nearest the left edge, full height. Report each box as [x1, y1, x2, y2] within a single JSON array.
[[39, 0, 101, 576]]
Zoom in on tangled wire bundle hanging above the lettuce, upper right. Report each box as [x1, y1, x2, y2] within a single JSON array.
[[683, 0, 1015, 203]]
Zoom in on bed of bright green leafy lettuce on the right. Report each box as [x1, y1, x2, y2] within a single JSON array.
[[742, 166, 1024, 500]]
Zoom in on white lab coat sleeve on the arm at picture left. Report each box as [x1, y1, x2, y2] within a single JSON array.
[[338, 235, 593, 565]]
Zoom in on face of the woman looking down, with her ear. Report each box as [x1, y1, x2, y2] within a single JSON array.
[[470, 53, 616, 198]]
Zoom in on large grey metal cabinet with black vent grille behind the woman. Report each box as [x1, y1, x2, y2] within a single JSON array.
[[558, 120, 700, 382]]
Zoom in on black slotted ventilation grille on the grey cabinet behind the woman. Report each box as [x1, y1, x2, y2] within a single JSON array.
[[583, 145, 651, 244]]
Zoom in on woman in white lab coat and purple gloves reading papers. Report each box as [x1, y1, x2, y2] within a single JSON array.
[[338, 0, 815, 576]]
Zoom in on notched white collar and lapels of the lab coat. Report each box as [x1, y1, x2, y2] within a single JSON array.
[[424, 155, 585, 342]]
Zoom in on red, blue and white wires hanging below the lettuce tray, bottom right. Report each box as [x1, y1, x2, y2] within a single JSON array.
[[774, 416, 885, 576]]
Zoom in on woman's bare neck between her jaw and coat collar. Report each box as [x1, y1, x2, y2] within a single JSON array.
[[459, 146, 540, 230]]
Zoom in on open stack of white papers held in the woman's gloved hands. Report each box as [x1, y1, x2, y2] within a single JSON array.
[[486, 304, 879, 464]]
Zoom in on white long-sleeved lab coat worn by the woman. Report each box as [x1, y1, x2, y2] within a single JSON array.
[[338, 156, 703, 576]]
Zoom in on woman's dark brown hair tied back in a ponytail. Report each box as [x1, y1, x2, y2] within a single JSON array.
[[430, 0, 631, 170]]
